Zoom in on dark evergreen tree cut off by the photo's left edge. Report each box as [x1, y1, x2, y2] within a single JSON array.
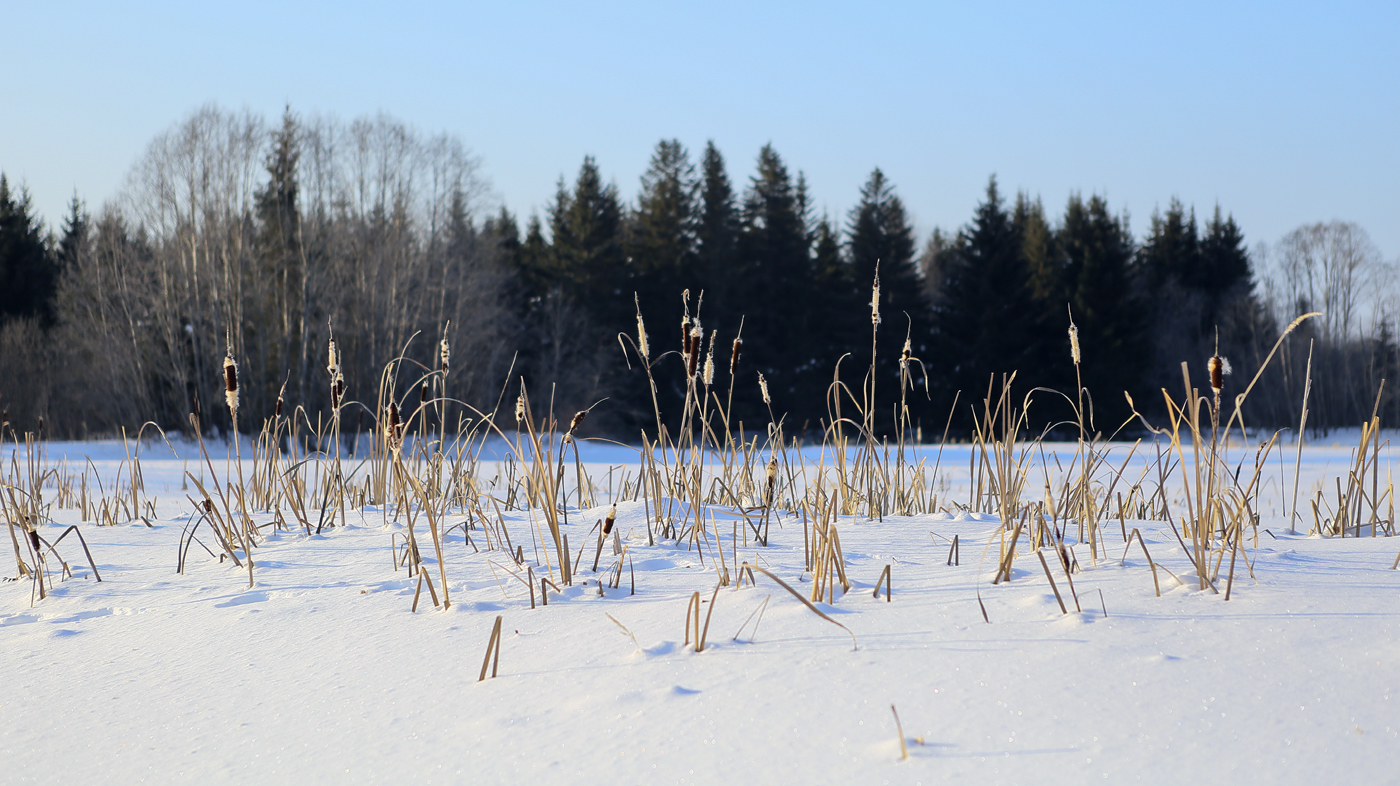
[[0, 172, 59, 326]]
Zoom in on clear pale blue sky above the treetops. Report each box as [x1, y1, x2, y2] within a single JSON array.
[[0, 0, 1400, 259]]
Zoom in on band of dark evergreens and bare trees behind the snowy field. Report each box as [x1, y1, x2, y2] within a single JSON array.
[[0, 106, 1400, 441]]
